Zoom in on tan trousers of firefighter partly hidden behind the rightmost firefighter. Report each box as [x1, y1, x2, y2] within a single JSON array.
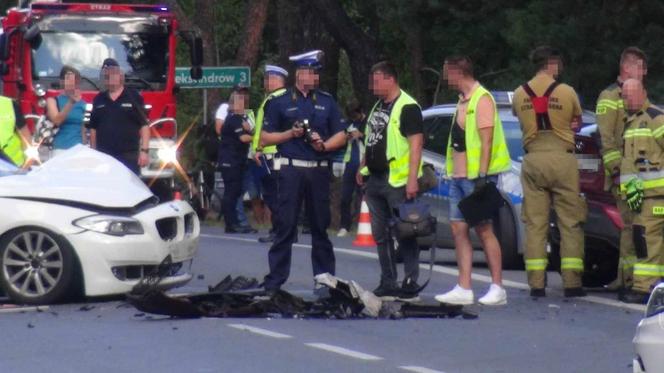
[[611, 186, 636, 288]]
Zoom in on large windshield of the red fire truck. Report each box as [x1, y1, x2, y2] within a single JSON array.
[[32, 16, 169, 89]]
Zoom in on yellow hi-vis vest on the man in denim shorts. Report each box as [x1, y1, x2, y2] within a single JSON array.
[[445, 86, 511, 179]]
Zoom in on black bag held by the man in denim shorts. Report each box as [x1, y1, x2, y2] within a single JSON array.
[[459, 182, 505, 227]]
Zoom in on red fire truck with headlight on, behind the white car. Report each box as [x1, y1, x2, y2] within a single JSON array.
[[0, 0, 203, 198]]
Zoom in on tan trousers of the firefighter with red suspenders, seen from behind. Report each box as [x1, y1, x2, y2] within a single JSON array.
[[521, 150, 587, 289]]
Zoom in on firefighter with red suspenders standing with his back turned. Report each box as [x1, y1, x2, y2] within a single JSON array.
[[512, 46, 586, 297]]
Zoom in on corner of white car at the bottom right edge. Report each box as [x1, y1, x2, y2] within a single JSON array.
[[632, 283, 664, 373]]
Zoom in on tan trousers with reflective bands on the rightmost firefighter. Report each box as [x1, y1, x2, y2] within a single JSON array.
[[633, 197, 664, 293]]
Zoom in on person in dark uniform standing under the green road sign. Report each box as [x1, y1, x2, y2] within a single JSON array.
[[218, 90, 252, 233]]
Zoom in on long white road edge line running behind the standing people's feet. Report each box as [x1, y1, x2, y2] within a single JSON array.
[[201, 234, 646, 312]]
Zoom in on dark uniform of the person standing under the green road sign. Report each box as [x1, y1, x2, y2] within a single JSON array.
[[218, 113, 249, 231]]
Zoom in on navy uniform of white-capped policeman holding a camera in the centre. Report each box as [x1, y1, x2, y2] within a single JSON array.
[[263, 88, 344, 290]]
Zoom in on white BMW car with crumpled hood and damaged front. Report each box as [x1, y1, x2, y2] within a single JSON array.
[[0, 145, 200, 304]]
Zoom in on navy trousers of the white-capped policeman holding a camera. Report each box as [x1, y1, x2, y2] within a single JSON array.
[[264, 165, 335, 289]]
